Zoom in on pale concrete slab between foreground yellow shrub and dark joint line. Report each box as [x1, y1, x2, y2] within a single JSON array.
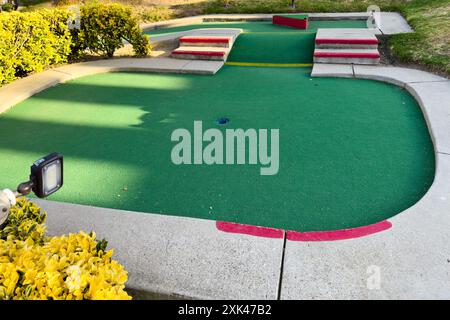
[[33, 200, 283, 299]]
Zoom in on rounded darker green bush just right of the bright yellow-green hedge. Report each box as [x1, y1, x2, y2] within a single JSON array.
[[77, 3, 149, 57]]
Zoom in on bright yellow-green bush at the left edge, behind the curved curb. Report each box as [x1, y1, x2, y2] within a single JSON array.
[[0, 10, 72, 84]]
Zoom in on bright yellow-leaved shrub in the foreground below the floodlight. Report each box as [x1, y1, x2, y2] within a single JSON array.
[[0, 199, 131, 300]]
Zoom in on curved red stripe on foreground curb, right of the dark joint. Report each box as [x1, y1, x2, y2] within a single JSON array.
[[286, 220, 392, 241]]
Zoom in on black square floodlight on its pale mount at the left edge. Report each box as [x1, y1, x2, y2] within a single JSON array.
[[0, 153, 63, 226]]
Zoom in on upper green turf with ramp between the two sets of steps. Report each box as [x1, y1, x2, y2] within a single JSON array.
[[147, 20, 366, 63]]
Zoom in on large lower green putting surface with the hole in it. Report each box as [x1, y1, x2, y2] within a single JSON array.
[[0, 66, 434, 231]]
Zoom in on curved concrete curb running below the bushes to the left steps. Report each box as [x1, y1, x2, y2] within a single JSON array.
[[0, 58, 224, 114]]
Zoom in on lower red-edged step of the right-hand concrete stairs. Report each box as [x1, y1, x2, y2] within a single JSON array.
[[314, 49, 380, 64]]
